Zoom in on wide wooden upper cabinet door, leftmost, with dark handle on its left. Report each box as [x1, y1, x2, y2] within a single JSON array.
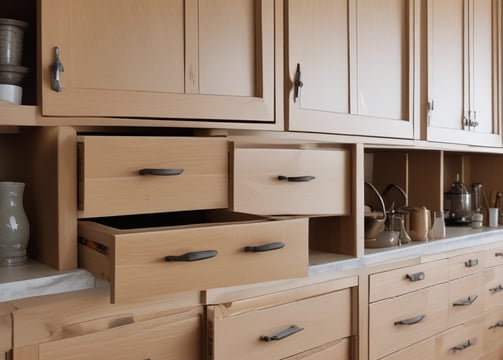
[[41, 0, 275, 123]]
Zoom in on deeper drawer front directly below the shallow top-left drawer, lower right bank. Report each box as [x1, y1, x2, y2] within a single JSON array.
[[369, 284, 448, 359]]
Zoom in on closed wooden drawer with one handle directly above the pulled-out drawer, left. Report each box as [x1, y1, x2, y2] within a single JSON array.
[[78, 136, 228, 218]]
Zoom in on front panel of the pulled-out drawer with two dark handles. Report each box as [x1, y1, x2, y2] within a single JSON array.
[[79, 218, 308, 302]]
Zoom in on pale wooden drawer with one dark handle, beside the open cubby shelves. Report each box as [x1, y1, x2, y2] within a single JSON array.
[[231, 148, 351, 215]]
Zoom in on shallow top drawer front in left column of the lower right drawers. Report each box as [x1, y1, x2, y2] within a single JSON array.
[[369, 259, 447, 302]]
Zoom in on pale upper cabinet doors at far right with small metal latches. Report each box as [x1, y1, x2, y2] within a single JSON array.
[[427, 0, 502, 146]]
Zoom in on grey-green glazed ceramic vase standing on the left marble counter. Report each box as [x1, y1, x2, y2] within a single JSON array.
[[0, 182, 30, 266]]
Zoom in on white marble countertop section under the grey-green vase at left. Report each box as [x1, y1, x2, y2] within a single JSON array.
[[0, 260, 95, 301]]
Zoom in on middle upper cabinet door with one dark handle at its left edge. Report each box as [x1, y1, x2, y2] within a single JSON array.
[[287, 0, 417, 138]]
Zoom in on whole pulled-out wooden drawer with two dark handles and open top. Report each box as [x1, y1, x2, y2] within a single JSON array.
[[79, 210, 308, 302]]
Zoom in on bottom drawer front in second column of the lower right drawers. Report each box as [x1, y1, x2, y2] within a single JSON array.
[[436, 319, 484, 360]]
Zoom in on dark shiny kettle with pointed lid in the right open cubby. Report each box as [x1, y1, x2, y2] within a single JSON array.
[[444, 174, 472, 225]]
